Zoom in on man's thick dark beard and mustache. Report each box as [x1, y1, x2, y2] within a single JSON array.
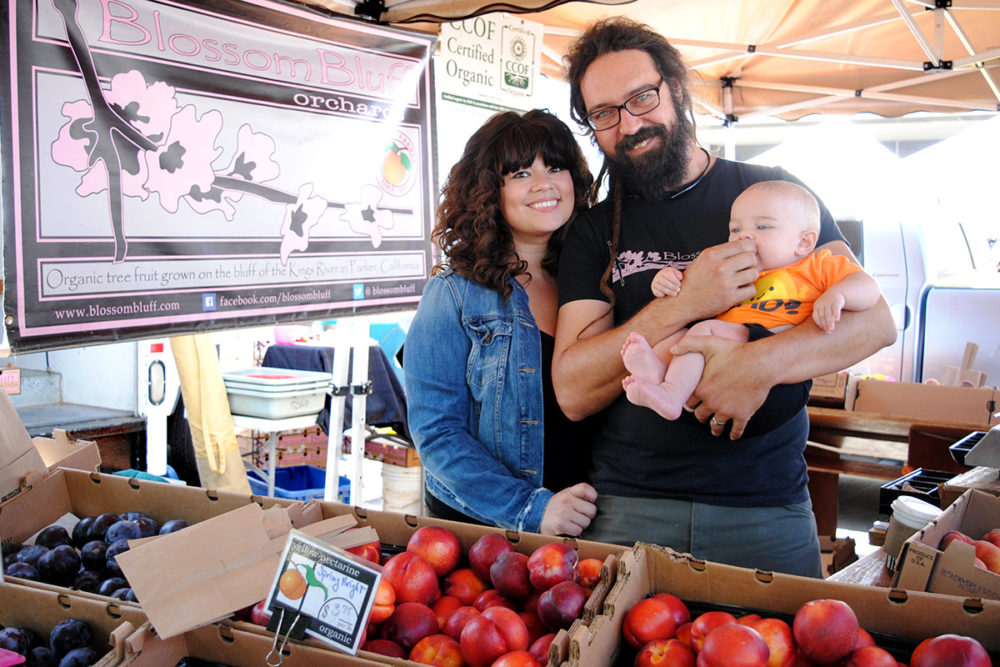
[[605, 114, 692, 201]]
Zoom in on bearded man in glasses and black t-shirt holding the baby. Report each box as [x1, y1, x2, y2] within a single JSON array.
[[553, 18, 895, 576]]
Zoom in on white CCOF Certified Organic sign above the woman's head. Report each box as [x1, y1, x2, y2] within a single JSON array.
[[436, 14, 544, 112]]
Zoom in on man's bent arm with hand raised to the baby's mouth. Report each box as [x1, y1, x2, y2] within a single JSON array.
[[552, 241, 757, 420]]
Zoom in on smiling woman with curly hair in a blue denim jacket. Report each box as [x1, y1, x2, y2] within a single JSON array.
[[404, 110, 597, 535]]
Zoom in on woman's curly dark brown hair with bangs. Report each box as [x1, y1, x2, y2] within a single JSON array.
[[431, 109, 594, 297]]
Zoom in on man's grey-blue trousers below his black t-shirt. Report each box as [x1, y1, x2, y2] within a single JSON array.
[[581, 495, 823, 577]]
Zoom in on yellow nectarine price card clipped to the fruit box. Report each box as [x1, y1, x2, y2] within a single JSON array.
[[267, 530, 382, 654]]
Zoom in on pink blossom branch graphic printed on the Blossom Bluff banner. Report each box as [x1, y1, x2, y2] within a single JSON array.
[[51, 0, 412, 263]]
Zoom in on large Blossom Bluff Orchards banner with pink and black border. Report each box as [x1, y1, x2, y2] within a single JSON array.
[[0, 0, 436, 352]]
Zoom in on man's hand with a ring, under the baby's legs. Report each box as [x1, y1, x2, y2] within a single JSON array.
[[671, 336, 772, 440]]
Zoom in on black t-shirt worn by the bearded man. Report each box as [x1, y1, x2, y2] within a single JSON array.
[[559, 160, 843, 506]]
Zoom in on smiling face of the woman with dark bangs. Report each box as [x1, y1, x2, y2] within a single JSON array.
[[500, 155, 574, 243]]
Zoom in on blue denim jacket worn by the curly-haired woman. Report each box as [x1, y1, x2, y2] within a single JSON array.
[[404, 270, 553, 532]]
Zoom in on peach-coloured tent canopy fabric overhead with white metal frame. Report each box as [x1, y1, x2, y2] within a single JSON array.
[[294, 0, 1000, 121]]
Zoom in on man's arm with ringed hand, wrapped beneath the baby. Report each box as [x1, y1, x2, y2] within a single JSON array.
[[671, 241, 896, 439]]
